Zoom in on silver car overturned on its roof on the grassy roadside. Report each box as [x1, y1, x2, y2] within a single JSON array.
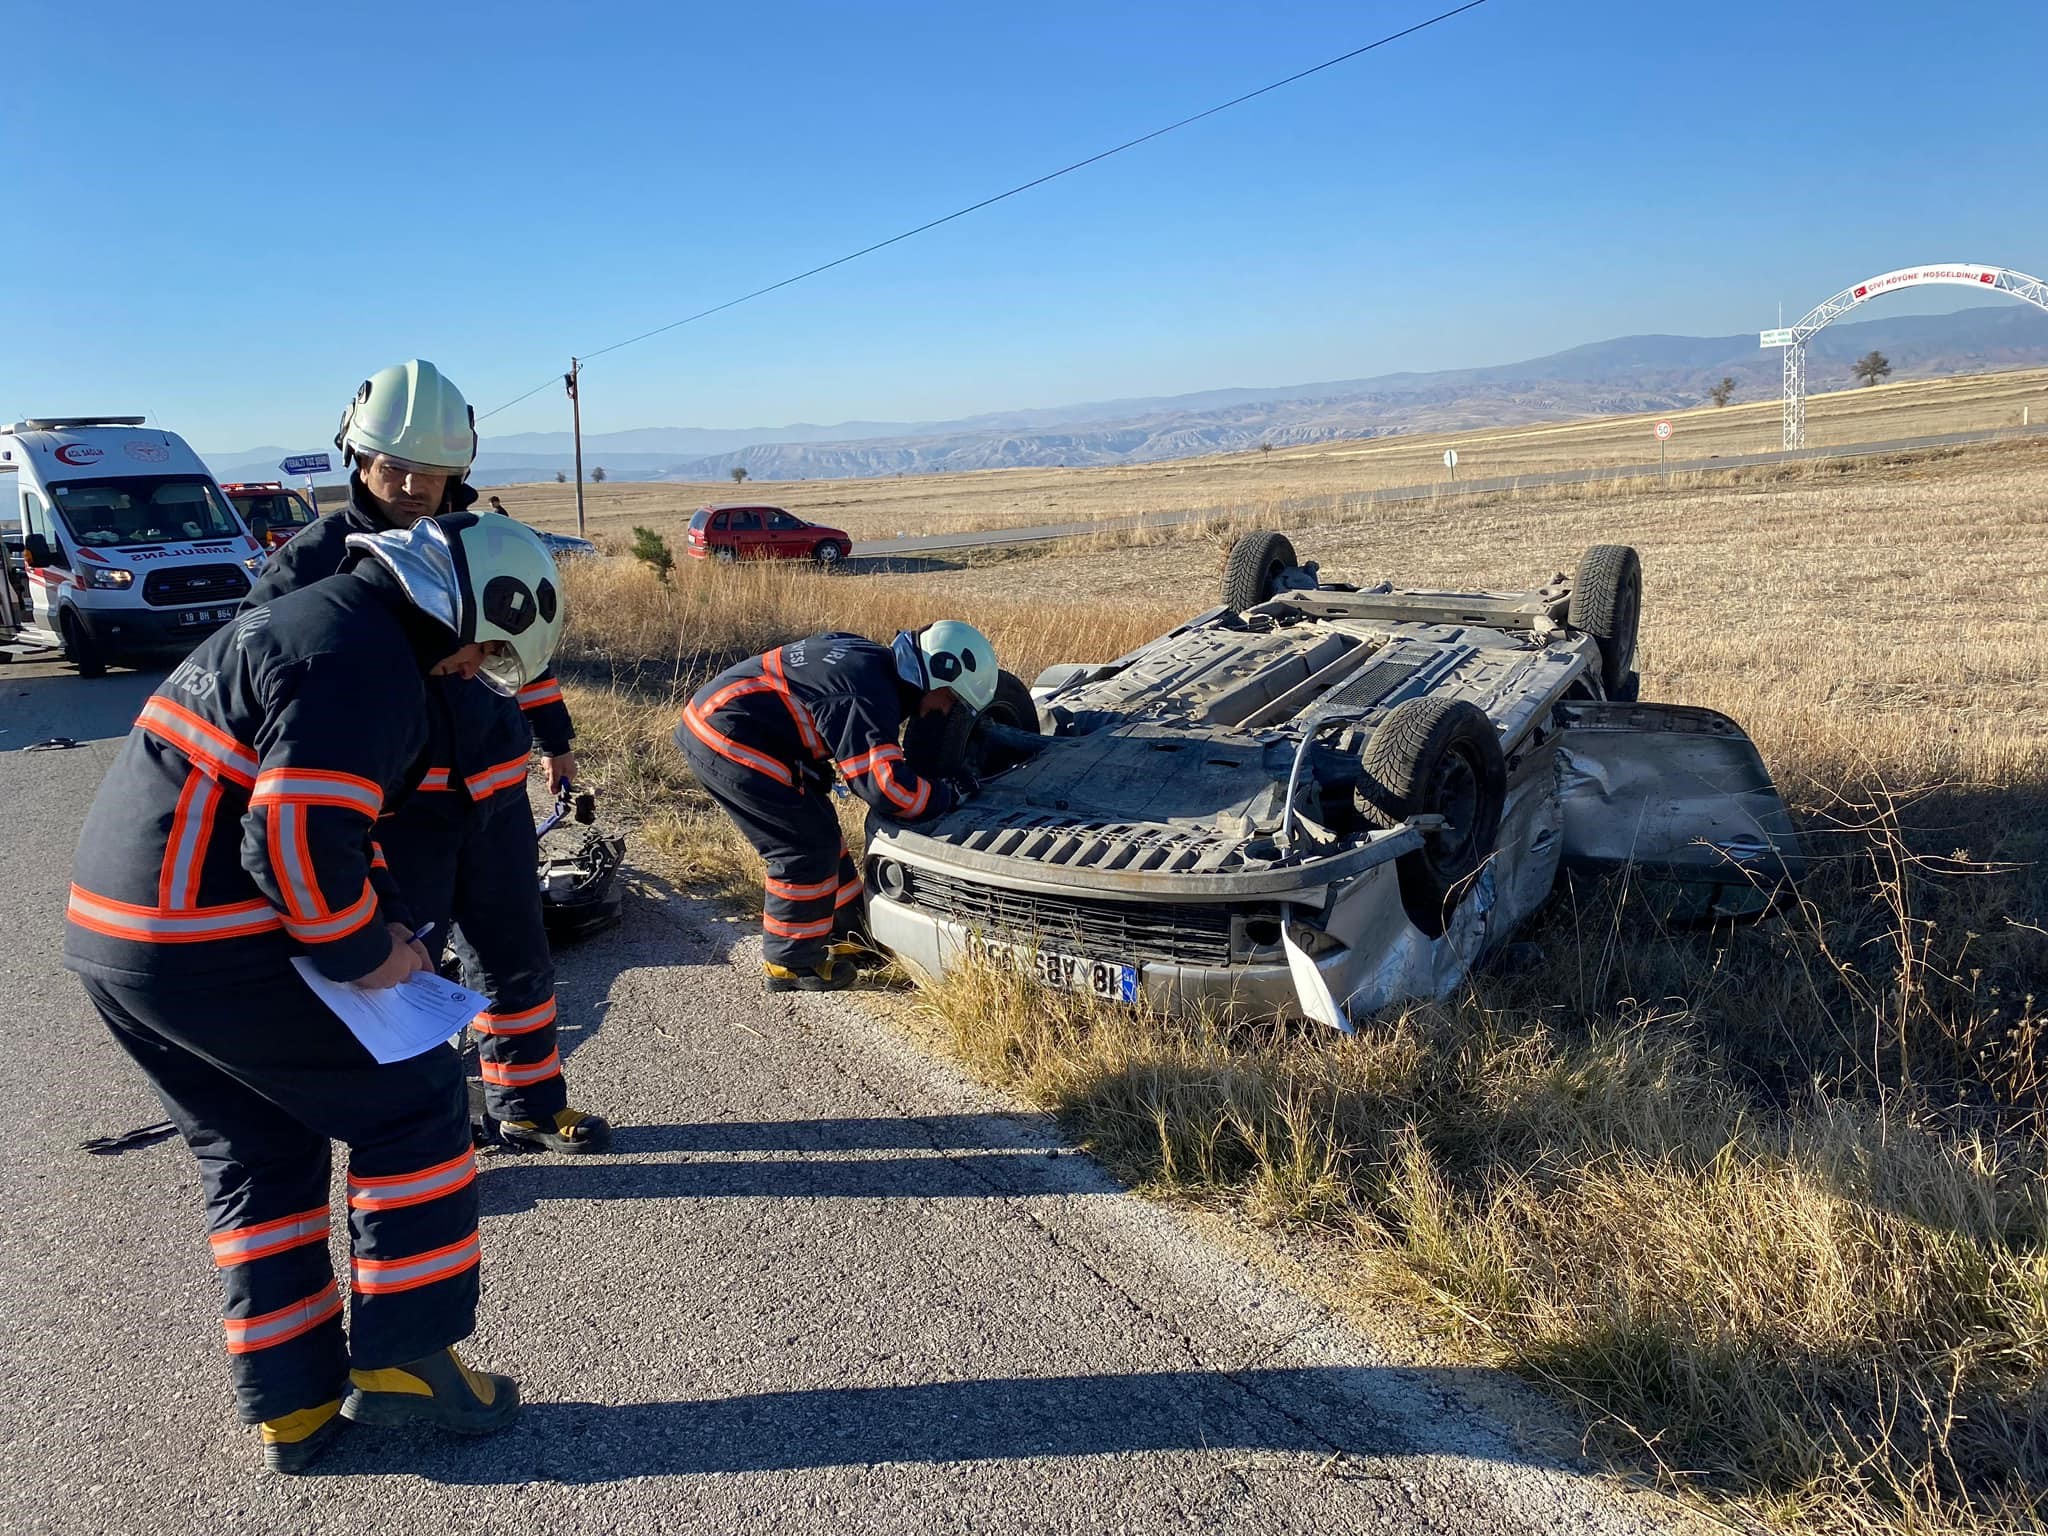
[[864, 532, 1800, 1028]]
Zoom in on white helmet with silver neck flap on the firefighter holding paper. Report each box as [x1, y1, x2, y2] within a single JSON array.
[[348, 512, 567, 694]]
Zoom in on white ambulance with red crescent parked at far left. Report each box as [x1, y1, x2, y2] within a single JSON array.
[[0, 428, 264, 678]]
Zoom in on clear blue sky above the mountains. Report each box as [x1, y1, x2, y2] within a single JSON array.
[[0, 0, 2048, 451]]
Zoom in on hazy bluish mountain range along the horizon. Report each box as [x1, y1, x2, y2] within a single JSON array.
[[209, 305, 2048, 485]]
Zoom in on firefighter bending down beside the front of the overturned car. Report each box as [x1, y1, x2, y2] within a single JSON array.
[[676, 618, 995, 991]]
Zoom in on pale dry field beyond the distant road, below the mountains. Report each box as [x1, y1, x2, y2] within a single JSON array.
[[494, 371, 2048, 541]]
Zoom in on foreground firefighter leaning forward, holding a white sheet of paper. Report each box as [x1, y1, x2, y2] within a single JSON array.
[[63, 514, 561, 1473]]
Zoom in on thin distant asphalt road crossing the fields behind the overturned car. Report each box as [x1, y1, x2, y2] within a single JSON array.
[[854, 426, 2048, 561]]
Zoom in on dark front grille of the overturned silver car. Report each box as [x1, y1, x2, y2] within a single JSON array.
[[897, 864, 1233, 967]]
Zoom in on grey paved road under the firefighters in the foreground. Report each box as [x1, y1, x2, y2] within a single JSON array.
[[0, 666, 1690, 1536]]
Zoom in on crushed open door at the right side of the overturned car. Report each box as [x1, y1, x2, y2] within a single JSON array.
[[1556, 702, 1804, 920]]
